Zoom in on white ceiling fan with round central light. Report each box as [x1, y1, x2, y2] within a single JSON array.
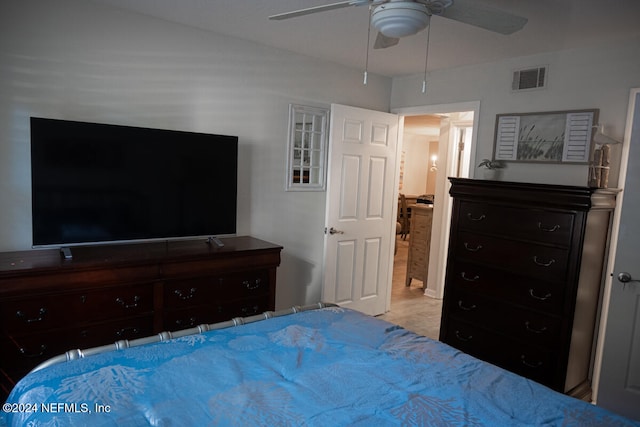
[[269, 0, 527, 49]]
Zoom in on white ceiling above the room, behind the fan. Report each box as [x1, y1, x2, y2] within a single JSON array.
[[93, 0, 640, 76]]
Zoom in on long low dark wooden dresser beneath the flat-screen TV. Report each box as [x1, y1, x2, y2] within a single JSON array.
[[0, 237, 282, 401]]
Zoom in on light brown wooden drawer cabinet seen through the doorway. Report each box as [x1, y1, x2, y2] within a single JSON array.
[[405, 203, 433, 288]]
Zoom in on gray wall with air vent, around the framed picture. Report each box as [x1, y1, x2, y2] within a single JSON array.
[[391, 37, 640, 186]]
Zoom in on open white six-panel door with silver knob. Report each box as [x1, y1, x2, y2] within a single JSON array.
[[322, 104, 398, 315]]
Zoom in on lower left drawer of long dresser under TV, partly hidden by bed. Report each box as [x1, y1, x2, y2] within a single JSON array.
[[0, 315, 153, 370]]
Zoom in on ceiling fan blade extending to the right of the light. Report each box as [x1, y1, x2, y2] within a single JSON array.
[[439, 0, 528, 35]]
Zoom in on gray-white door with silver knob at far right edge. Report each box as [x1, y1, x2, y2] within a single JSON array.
[[597, 89, 640, 420]]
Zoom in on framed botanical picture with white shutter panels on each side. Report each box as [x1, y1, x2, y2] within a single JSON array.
[[493, 109, 599, 164]]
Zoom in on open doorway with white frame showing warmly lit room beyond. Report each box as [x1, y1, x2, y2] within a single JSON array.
[[378, 102, 479, 339]]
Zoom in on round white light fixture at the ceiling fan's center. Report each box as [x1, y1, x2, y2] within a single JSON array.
[[371, 1, 430, 38]]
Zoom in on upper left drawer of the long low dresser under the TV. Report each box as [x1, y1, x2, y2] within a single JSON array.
[[0, 284, 153, 335]]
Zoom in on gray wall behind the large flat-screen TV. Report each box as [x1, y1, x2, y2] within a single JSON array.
[[0, 0, 391, 308]]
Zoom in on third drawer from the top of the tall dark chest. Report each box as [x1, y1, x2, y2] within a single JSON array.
[[447, 260, 566, 315]]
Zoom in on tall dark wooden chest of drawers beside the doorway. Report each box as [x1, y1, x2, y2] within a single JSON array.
[[440, 178, 616, 399]]
